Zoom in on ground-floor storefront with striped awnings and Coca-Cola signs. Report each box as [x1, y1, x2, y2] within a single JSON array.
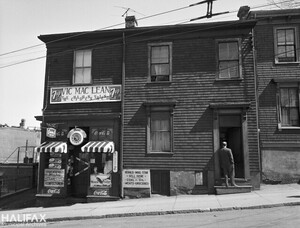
[[36, 122, 119, 200]]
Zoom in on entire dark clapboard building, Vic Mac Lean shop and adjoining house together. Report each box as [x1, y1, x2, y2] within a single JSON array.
[[36, 17, 260, 201]]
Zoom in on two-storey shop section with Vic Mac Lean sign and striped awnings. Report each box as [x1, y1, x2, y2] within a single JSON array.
[[36, 29, 122, 201]]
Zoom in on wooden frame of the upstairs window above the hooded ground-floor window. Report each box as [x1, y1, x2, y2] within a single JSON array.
[[148, 42, 173, 83]]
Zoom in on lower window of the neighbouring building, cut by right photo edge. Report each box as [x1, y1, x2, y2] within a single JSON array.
[[277, 83, 300, 128]]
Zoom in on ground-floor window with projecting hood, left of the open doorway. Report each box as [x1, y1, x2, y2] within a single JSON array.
[[147, 106, 173, 153]]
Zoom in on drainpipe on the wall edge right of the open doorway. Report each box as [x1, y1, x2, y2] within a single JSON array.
[[252, 28, 262, 182]]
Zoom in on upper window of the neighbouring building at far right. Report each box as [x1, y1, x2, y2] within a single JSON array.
[[274, 28, 298, 63]]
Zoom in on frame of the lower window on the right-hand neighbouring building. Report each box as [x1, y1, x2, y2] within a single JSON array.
[[276, 82, 300, 130]]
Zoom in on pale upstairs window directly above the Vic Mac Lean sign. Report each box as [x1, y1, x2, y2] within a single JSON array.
[[73, 50, 92, 84]]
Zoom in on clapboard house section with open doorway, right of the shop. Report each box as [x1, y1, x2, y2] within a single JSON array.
[[122, 17, 260, 196]]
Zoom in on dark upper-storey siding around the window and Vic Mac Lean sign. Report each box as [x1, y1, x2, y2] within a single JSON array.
[[44, 39, 122, 114]]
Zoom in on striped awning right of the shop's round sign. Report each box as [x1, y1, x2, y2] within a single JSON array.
[[81, 141, 115, 153]]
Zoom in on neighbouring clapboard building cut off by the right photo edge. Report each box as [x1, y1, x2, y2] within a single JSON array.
[[240, 7, 300, 183]]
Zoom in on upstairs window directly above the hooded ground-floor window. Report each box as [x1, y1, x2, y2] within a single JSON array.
[[149, 43, 172, 82]]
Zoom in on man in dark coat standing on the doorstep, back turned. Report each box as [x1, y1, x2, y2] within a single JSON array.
[[219, 142, 237, 187]]
